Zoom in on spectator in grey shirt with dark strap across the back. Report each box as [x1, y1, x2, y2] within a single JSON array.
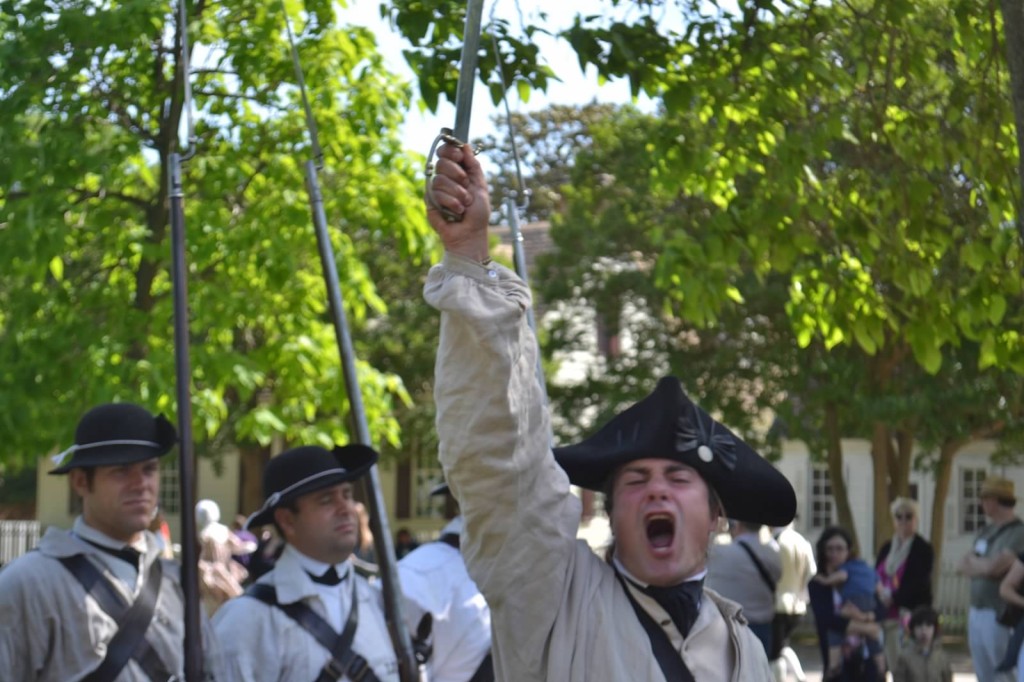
[[705, 520, 782, 655]]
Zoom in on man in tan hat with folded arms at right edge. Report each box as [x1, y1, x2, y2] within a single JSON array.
[[957, 476, 1024, 682]]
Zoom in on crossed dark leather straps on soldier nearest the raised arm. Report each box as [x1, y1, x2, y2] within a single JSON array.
[[245, 576, 379, 682]]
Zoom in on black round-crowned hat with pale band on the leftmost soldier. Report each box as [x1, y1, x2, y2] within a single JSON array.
[[50, 402, 178, 474]]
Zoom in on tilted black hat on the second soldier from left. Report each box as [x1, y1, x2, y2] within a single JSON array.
[[246, 443, 377, 528]]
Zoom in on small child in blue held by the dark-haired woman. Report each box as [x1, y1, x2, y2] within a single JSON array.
[[813, 558, 886, 680]]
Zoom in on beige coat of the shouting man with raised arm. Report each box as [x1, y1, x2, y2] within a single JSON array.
[[424, 255, 772, 682]]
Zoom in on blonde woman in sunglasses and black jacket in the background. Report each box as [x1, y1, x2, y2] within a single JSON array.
[[874, 498, 935, 666]]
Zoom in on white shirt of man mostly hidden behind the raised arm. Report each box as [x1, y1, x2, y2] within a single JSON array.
[[398, 517, 490, 682]]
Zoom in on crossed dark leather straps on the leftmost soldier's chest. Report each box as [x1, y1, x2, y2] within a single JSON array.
[[59, 554, 171, 682]]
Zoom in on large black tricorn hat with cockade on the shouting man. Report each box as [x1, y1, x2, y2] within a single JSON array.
[[554, 377, 797, 525]]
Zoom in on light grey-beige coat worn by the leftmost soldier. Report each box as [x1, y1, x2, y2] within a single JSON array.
[[0, 528, 222, 682]]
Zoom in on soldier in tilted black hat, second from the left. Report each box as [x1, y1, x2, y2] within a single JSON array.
[[213, 444, 398, 682]]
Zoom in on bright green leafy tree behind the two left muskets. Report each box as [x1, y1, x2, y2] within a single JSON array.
[[0, 0, 433, 464]]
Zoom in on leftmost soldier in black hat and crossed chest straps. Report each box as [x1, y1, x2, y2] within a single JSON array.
[[0, 403, 221, 682]]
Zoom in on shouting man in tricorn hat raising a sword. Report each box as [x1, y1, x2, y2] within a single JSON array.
[[424, 140, 796, 682]]
